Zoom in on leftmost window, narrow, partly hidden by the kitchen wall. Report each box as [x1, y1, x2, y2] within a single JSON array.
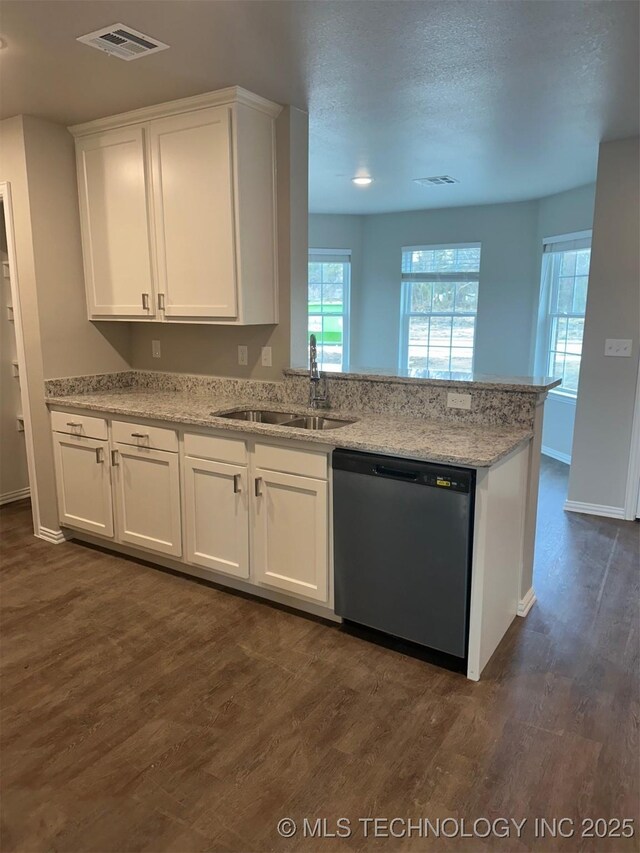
[[308, 249, 351, 373]]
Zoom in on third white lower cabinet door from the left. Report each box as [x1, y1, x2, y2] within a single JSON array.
[[184, 456, 249, 578]]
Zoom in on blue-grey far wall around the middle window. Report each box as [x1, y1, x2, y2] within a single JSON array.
[[309, 201, 539, 375]]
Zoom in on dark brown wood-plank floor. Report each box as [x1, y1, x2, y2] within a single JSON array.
[[0, 460, 640, 853]]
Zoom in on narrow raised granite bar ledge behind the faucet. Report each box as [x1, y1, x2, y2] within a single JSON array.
[[284, 367, 562, 394]]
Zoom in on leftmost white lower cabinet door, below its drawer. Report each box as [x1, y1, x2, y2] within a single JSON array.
[[53, 432, 113, 536]]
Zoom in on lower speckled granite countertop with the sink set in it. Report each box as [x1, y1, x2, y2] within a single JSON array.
[[47, 388, 532, 468]]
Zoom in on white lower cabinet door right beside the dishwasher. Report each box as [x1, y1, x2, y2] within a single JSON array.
[[254, 468, 329, 602]]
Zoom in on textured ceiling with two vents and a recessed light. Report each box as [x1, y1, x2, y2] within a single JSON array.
[[0, 0, 640, 213]]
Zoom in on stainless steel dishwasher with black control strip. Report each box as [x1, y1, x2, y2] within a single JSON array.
[[333, 450, 475, 669]]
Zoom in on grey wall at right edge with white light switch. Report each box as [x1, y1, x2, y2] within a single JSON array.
[[569, 137, 640, 515]]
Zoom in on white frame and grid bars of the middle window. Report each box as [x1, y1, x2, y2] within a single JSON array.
[[398, 240, 482, 373]]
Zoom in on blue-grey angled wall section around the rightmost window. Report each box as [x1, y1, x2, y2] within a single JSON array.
[[533, 184, 596, 463]]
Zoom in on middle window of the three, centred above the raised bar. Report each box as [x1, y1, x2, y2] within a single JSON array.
[[400, 244, 480, 375]]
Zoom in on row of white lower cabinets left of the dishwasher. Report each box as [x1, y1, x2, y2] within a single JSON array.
[[51, 412, 331, 605]]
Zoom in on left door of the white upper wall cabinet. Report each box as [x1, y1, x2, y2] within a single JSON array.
[[76, 127, 155, 319]]
